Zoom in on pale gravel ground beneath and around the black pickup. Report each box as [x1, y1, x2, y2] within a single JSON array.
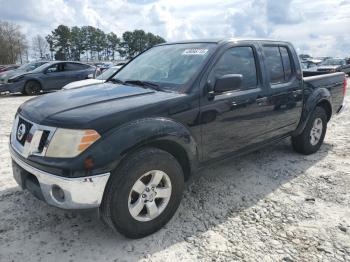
[[0, 84, 350, 262]]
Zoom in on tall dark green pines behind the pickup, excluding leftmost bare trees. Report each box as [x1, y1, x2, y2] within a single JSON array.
[[44, 25, 165, 61]]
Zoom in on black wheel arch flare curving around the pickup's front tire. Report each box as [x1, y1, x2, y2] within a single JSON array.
[[87, 118, 198, 180]]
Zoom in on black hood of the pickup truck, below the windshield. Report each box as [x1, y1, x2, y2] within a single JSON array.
[[19, 82, 183, 132]]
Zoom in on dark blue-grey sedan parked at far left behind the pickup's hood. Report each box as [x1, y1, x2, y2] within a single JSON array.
[[0, 61, 96, 95]]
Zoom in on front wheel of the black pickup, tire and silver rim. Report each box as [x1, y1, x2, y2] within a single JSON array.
[[100, 148, 184, 238]]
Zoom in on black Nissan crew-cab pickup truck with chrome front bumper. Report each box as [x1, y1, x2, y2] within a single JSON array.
[[10, 39, 346, 238]]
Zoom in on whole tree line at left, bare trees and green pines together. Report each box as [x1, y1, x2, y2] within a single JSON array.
[[0, 20, 165, 64]]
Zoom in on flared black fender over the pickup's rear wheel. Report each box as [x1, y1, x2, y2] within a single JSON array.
[[293, 88, 331, 136]]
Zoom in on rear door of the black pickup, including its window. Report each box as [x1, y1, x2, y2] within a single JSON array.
[[261, 44, 303, 136]]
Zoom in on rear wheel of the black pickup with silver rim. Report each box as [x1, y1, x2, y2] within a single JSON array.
[[292, 107, 328, 155]]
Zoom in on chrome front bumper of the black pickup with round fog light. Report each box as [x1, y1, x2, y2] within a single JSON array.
[[10, 145, 110, 209]]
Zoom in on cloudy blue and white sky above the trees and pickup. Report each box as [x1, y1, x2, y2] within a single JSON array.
[[0, 0, 350, 56]]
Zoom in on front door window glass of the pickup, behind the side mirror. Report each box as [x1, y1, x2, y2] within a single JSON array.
[[208, 46, 258, 90]]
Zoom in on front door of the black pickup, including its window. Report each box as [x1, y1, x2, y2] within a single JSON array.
[[200, 45, 273, 161]]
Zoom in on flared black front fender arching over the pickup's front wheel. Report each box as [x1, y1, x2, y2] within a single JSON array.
[[84, 117, 198, 176]]
